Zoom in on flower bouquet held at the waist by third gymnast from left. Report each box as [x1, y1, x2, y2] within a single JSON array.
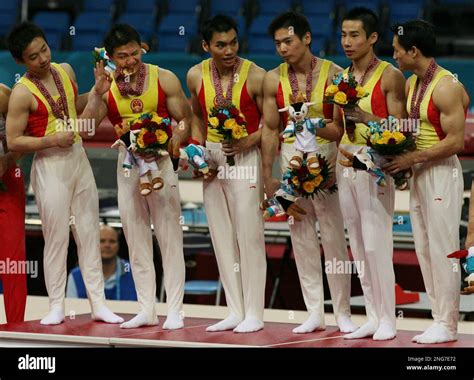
[[207, 104, 248, 166]]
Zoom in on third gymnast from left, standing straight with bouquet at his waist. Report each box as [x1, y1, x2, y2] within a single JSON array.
[[187, 15, 266, 333]]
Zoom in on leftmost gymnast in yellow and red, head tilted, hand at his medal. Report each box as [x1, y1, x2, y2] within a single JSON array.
[[7, 23, 123, 325]]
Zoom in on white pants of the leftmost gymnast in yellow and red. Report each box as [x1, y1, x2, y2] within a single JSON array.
[[31, 143, 105, 312]]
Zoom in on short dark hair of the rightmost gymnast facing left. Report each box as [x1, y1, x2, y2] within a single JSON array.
[[392, 20, 436, 57]]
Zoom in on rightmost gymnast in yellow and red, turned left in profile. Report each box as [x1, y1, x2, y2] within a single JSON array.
[[385, 20, 469, 344]]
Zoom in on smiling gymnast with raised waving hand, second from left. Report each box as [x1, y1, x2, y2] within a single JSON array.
[[83, 24, 191, 329]]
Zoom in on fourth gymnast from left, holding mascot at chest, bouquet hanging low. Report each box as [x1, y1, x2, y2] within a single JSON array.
[[262, 12, 357, 334]]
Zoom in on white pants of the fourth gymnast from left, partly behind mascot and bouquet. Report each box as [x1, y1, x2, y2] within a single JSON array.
[[281, 142, 351, 321]]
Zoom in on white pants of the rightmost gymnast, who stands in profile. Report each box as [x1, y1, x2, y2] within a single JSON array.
[[410, 156, 464, 335]]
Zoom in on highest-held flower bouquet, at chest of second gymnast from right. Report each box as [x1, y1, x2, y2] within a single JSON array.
[[323, 73, 369, 141]]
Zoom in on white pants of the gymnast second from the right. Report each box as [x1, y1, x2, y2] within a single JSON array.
[[336, 144, 396, 329]]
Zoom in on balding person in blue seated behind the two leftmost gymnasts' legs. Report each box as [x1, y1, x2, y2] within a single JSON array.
[[66, 226, 137, 301]]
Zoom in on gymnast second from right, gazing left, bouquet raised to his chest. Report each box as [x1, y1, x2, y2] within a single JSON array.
[[337, 8, 406, 340]]
